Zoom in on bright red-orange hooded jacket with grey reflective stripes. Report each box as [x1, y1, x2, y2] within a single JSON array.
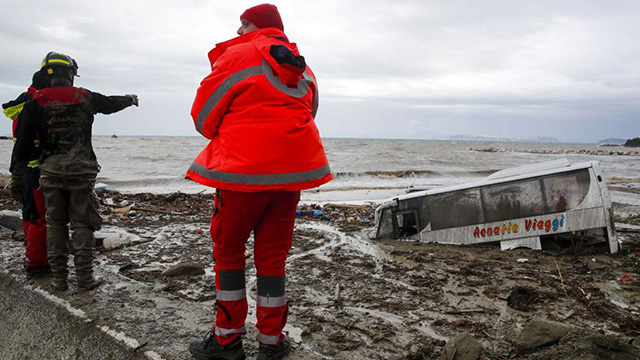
[[186, 28, 332, 191]]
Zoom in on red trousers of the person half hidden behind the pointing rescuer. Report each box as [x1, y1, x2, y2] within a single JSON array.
[[22, 189, 49, 270]]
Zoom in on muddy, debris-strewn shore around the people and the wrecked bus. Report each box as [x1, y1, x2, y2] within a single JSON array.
[[0, 179, 640, 359]]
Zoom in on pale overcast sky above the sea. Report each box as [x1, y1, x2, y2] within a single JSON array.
[[0, 0, 640, 142]]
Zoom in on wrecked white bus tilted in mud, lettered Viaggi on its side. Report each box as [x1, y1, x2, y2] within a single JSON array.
[[376, 159, 618, 253]]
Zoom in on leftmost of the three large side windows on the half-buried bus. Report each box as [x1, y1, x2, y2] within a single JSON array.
[[427, 188, 483, 230]]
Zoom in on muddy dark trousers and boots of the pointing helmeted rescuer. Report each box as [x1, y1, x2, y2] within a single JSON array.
[[41, 176, 102, 286]]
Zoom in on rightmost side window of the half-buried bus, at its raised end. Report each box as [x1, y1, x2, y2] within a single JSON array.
[[543, 169, 591, 212]]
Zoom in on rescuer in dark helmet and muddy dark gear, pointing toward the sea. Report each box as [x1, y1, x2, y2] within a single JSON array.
[[11, 52, 138, 291]]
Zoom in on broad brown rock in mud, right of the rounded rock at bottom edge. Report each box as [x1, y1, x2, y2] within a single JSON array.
[[515, 321, 571, 355]]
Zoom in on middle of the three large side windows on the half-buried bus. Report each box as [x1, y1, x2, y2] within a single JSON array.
[[482, 179, 545, 222]]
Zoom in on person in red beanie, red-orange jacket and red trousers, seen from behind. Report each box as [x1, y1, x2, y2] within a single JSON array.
[[186, 4, 332, 360]]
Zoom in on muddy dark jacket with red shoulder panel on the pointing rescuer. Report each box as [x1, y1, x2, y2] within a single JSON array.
[[10, 86, 133, 177]]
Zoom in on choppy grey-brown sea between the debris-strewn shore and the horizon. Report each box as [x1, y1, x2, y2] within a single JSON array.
[[0, 136, 640, 202]]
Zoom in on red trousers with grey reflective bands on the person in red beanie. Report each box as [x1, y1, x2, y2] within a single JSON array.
[[211, 190, 300, 346]]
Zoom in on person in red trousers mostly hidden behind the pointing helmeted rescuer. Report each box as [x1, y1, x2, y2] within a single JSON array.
[[2, 70, 50, 276]]
